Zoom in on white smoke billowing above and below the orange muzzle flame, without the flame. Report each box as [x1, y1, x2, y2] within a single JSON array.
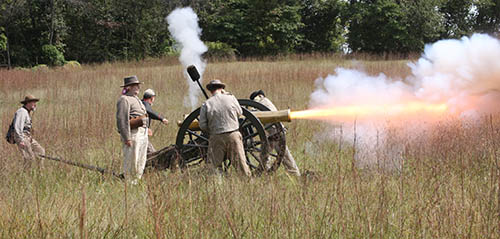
[[309, 34, 500, 168]]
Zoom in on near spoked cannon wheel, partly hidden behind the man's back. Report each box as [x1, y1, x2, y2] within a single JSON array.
[[176, 103, 269, 173]]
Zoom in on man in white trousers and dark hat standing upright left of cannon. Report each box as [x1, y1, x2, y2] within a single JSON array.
[[116, 76, 149, 184]]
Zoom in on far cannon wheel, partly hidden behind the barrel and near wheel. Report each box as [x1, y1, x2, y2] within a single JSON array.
[[238, 99, 286, 172]]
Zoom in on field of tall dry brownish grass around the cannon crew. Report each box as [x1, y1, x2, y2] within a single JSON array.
[[0, 56, 500, 238]]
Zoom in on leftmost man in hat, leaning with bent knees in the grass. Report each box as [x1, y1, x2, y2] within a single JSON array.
[[7, 95, 45, 167]]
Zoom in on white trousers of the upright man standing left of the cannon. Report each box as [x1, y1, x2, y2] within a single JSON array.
[[122, 127, 148, 180]]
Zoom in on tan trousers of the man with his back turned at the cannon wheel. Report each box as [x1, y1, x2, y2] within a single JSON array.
[[208, 131, 252, 176]]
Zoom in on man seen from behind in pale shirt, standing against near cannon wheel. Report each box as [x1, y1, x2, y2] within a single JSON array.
[[200, 80, 252, 176]]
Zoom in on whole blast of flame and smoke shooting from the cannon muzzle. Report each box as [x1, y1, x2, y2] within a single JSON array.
[[291, 34, 500, 166]]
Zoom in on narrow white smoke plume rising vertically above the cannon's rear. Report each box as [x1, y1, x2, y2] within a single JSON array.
[[166, 7, 208, 109]]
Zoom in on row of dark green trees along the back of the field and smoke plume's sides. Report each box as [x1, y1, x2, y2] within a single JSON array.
[[0, 0, 500, 67]]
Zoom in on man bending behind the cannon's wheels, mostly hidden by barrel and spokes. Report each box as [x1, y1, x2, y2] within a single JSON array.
[[250, 90, 300, 176]]
